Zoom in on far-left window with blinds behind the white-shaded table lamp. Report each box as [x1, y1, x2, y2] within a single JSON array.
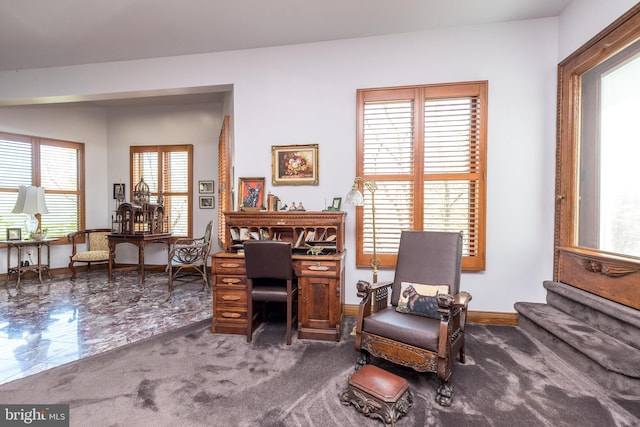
[[0, 133, 84, 239]]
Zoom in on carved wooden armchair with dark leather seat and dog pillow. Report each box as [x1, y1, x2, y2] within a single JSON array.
[[355, 231, 471, 406]]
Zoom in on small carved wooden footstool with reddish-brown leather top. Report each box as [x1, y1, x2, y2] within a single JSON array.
[[340, 365, 413, 426]]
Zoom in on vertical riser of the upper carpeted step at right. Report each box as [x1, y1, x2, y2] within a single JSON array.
[[547, 289, 640, 350]]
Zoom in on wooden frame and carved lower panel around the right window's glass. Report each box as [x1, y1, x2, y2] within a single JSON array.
[[553, 4, 640, 309]]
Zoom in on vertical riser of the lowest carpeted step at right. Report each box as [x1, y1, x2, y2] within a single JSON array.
[[519, 314, 640, 397]]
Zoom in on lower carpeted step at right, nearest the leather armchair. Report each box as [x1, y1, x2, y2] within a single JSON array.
[[515, 302, 640, 397]]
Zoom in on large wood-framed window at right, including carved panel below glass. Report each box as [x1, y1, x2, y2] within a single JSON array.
[[554, 4, 640, 309]]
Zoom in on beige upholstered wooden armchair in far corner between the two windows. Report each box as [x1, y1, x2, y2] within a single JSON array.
[[67, 228, 111, 279]]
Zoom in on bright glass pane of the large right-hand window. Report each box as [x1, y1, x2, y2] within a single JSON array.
[[578, 37, 640, 257]]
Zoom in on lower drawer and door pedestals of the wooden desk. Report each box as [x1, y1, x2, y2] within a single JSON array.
[[211, 252, 345, 341]]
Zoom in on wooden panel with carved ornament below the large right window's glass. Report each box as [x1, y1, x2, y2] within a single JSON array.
[[558, 248, 640, 310]]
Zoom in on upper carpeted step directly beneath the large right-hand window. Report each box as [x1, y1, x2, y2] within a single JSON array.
[[544, 281, 640, 349]]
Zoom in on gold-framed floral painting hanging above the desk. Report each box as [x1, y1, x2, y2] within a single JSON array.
[[271, 144, 319, 185]]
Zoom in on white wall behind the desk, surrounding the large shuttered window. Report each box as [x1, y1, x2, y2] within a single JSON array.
[[0, 7, 624, 312]]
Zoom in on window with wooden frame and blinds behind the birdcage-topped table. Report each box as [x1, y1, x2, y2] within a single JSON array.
[[131, 145, 193, 237]]
